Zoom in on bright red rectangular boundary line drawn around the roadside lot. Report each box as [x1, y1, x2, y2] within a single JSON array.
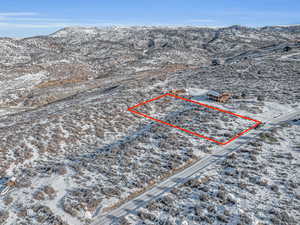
[[127, 93, 262, 145]]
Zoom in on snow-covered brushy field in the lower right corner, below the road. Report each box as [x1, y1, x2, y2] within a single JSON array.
[[126, 118, 300, 224]]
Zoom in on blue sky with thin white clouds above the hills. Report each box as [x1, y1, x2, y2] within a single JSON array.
[[0, 0, 300, 37]]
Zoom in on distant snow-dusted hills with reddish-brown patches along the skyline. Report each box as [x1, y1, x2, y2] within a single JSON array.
[[0, 26, 300, 110]]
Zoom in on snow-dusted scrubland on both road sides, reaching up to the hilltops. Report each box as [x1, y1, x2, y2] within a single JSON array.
[[0, 26, 300, 225]]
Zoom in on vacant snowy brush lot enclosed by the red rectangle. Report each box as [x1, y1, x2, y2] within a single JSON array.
[[131, 95, 257, 143]]
